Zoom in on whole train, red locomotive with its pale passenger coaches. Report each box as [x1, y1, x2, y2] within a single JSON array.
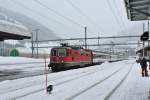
[[48, 44, 126, 72]]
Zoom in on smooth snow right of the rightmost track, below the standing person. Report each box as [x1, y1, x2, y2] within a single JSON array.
[[110, 61, 150, 100]]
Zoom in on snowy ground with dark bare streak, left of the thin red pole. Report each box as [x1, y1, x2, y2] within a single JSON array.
[[0, 57, 48, 81]]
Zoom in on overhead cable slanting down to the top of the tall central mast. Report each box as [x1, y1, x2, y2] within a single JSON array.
[[34, 0, 83, 28]]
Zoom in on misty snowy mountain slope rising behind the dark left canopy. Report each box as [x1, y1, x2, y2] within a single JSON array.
[[0, 7, 60, 40]]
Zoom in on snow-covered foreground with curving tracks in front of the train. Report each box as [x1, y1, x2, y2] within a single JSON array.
[[0, 60, 150, 100]]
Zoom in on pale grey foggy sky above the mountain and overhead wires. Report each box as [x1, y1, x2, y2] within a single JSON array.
[[0, 0, 146, 38]]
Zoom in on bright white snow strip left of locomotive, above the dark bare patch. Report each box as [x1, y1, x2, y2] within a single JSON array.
[[0, 57, 49, 71]]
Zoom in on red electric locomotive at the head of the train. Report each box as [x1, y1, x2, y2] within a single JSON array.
[[49, 46, 93, 71]]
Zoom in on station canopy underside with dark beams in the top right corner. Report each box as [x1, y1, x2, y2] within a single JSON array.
[[124, 0, 150, 21]]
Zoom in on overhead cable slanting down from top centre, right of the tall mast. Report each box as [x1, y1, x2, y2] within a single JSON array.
[[66, 0, 104, 32]]
